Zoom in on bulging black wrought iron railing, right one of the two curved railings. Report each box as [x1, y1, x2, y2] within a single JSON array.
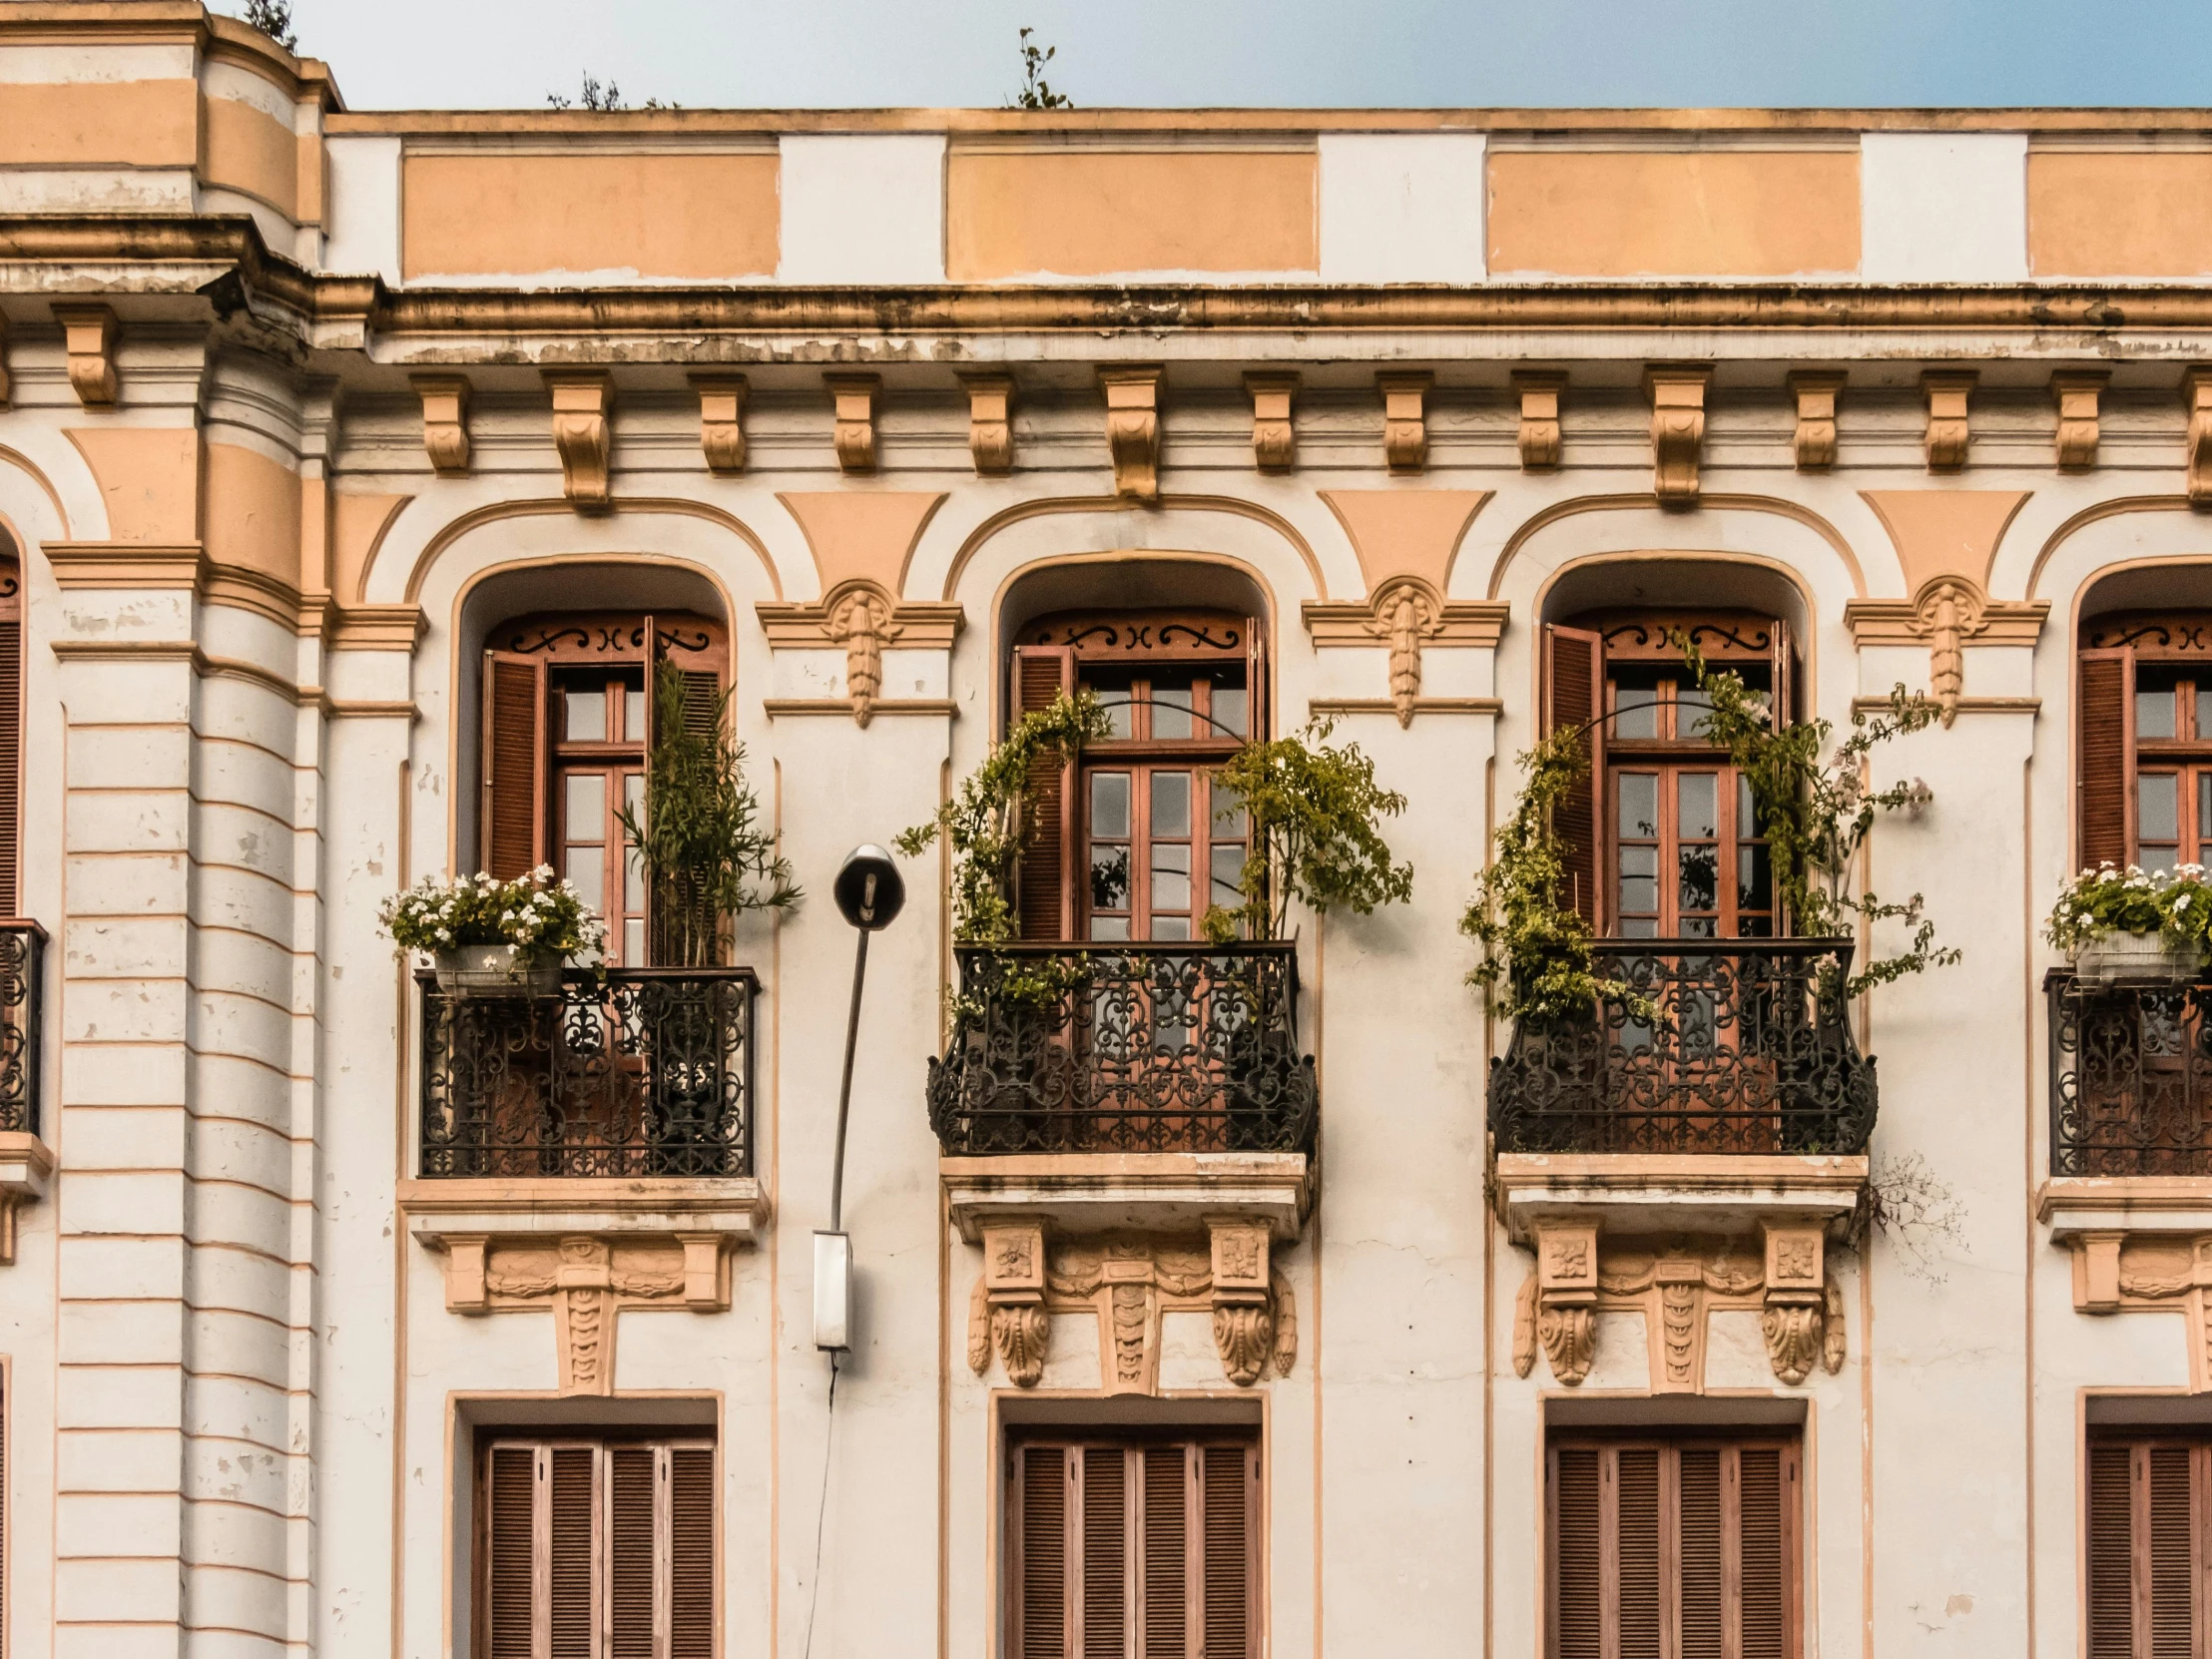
[[1491, 938, 1876, 1155]]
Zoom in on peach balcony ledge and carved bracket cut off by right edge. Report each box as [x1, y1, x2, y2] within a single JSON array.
[[2035, 1175, 2212, 1393]]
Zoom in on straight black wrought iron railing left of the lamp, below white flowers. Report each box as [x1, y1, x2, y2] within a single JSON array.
[[418, 969, 759, 1179]]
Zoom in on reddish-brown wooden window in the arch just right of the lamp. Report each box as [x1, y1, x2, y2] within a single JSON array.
[[1011, 608, 1268, 940]]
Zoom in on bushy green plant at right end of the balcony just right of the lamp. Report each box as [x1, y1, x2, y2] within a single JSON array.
[[1204, 721, 1413, 944]]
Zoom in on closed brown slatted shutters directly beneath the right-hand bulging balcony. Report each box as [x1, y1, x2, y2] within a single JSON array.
[[1544, 1429, 1803, 1659]]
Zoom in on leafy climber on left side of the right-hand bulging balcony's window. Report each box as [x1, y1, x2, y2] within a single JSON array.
[[1460, 728, 1655, 1022]]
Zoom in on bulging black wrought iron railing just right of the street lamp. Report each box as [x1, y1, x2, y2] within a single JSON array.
[[929, 940, 1321, 1155]]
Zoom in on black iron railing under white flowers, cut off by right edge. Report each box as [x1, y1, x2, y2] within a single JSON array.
[[2044, 969, 2212, 1175]]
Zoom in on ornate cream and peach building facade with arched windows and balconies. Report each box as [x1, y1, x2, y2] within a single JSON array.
[[0, 0, 2212, 1659]]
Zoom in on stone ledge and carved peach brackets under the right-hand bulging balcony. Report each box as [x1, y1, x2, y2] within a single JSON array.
[[1495, 1153, 1867, 1393]]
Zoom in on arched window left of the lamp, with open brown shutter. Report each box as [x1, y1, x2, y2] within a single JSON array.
[[478, 613, 730, 966]]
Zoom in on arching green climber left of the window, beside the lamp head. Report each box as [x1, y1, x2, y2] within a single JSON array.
[[893, 693, 1108, 944]]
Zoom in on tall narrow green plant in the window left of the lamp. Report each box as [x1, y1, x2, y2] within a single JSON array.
[[617, 664, 801, 966]]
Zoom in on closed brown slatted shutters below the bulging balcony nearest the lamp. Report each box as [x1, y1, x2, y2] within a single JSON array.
[[1000, 1429, 1263, 1659]]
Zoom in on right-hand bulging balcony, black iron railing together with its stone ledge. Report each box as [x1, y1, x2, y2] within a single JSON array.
[[1488, 938, 1876, 1237]]
